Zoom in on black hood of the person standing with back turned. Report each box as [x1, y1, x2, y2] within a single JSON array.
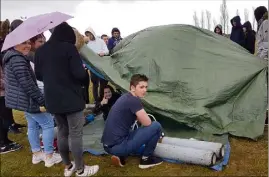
[[49, 22, 76, 44]]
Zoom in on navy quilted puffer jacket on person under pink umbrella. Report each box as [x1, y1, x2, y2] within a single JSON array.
[[3, 49, 45, 113]]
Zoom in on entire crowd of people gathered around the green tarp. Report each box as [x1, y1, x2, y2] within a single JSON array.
[[0, 4, 268, 176]]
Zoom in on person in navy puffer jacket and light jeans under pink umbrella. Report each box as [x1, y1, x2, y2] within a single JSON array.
[[3, 36, 62, 167]]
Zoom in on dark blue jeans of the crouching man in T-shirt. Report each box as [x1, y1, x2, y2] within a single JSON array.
[[104, 121, 162, 157]]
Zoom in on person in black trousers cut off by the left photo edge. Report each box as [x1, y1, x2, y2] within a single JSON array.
[[0, 20, 22, 154]]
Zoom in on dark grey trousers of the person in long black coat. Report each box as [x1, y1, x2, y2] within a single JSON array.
[[55, 111, 84, 170]]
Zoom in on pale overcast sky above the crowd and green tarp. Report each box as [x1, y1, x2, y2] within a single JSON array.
[[1, 0, 268, 36]]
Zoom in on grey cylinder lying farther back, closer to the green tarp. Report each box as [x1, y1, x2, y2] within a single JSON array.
[[160, 137, 225, 158]]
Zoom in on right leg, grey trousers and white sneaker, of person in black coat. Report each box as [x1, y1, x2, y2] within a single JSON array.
[[67, 111, 99, 176]]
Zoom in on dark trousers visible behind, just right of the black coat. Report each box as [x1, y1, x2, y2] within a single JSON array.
[[90, 72, 108, 102]]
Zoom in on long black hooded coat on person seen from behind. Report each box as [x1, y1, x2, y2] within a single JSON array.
[[34, 23, 88, 114]]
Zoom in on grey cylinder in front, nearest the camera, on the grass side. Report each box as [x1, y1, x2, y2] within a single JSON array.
[[154, 143, 217, 166]]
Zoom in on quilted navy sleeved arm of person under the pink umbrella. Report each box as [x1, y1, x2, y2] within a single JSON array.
[[10, 56, 45, 106]]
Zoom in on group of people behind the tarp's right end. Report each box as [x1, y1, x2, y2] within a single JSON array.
[[214, 6, 268, 59]]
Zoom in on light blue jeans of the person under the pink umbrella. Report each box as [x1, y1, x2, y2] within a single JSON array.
[[25, 112, 54, 154]]
